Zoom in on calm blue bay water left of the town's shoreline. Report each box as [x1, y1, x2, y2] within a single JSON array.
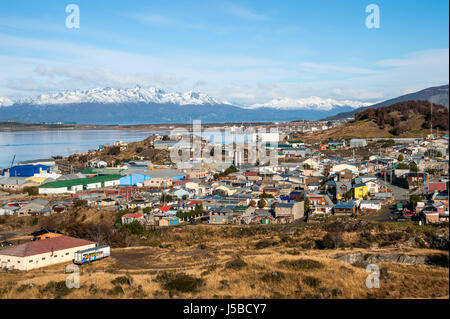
[[0, 130, 168, 169]]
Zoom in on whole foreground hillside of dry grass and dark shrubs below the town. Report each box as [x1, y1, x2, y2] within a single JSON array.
[[0, 210, 449, 299]]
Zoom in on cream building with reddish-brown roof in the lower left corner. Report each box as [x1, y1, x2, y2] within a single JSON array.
[[0, 236, 96, 271]]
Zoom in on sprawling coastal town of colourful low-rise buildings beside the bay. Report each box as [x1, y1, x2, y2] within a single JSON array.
[[0, 121, 449, 278]]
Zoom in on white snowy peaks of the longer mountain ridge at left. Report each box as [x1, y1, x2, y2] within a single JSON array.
[[4, 86, 230, 106]]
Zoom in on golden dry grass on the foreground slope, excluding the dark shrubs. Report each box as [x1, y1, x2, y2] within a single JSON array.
[[0, 226, 449, 298]]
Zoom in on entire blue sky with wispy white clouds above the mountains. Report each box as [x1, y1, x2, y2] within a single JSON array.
[[0, 0, 449, 106]]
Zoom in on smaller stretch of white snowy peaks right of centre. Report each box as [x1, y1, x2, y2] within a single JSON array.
[[248, 96, 373, 111]]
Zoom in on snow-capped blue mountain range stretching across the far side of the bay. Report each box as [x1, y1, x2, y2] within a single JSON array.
[[0, 85, 448, 124]]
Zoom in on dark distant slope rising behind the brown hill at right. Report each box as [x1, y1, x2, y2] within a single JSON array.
[[324, 84, 449, 120]]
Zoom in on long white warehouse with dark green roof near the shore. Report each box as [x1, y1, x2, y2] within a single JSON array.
[[39, 174, 122, 194]]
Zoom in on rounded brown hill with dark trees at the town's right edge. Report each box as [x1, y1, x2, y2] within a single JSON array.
[[304, 101, 449, 141]]
